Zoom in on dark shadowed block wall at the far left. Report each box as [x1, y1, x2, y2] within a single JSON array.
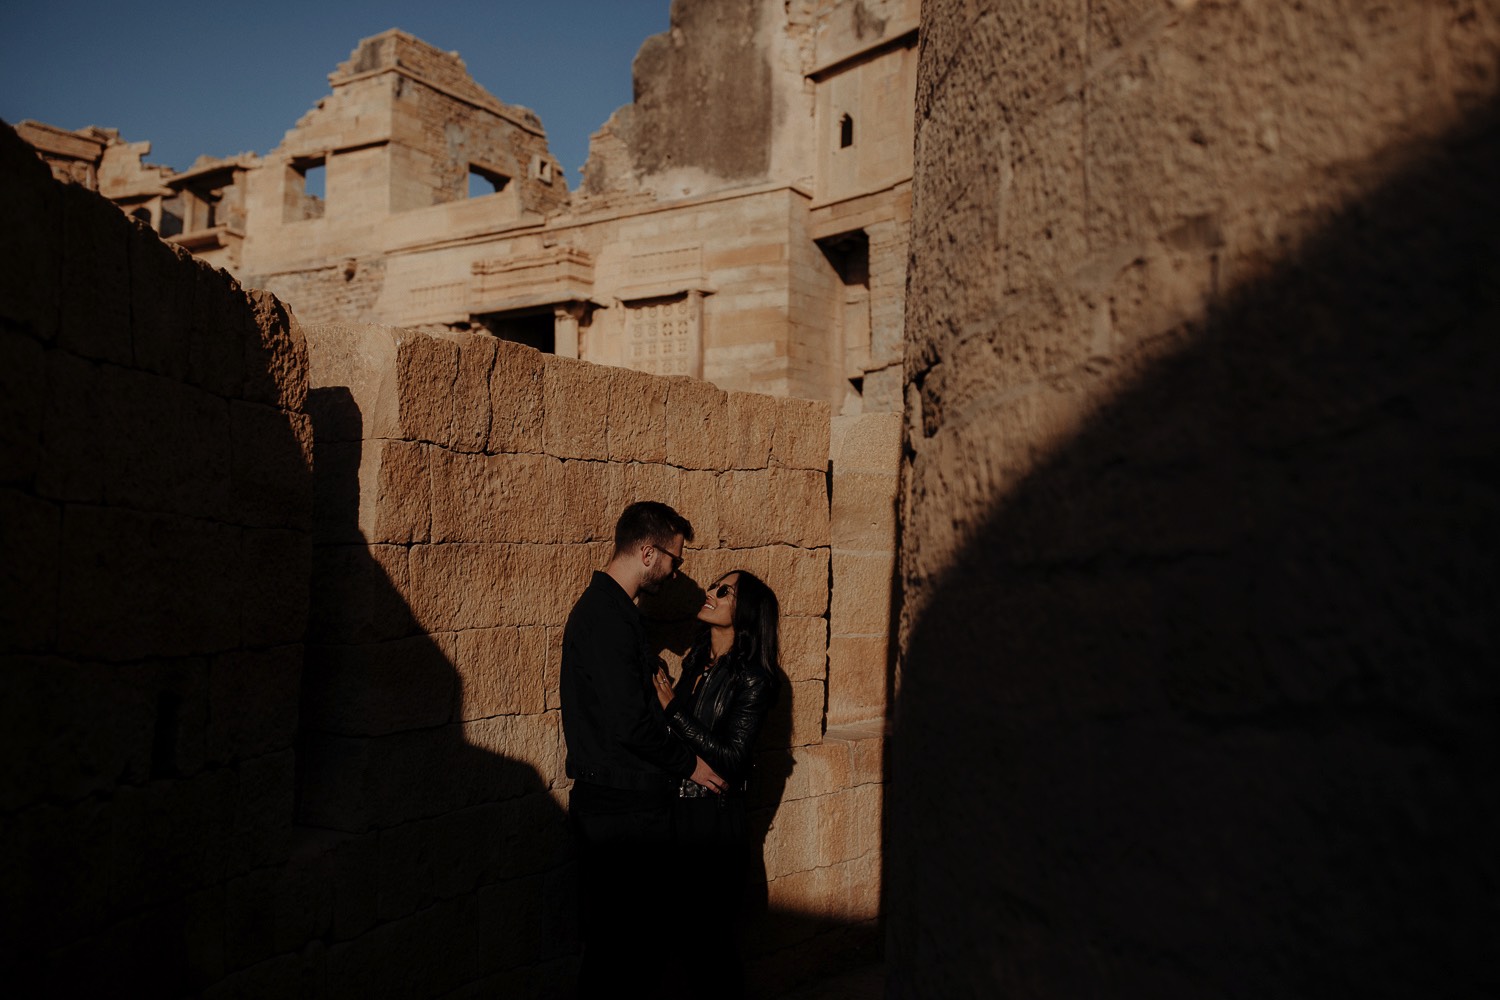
[[0, 127, 312, 993]]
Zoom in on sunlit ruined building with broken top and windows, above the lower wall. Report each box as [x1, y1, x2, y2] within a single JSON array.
[[23, 0, 920, 412]]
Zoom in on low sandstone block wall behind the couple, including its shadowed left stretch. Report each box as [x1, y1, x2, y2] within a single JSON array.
[[0, 115, 900, 1000]]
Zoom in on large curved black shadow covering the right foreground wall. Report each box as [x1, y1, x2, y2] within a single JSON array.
[[885, 101, 1500, 997]]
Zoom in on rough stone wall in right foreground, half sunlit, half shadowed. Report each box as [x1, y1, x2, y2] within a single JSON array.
[[887, 0, 1500, 997]]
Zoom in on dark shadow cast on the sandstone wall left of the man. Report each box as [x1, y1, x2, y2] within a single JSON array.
[[297, 387, 578, 999]]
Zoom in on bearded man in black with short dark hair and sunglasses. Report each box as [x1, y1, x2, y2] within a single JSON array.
[[561, 501, 725, 997]]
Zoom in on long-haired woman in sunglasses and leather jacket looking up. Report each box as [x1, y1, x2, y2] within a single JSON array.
[[656, 570, 782, 997]]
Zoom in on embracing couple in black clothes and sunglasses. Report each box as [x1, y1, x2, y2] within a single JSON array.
[[561, 501, 780, 997]]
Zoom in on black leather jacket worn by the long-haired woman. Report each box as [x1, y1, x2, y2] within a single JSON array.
[[666, 653, 776, 798]]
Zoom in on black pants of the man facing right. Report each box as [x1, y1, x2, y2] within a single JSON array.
[[569, 781, 672, 999]]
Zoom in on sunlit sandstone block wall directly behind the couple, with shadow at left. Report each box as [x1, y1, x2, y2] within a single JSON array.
[[299, 325, 894, 987]]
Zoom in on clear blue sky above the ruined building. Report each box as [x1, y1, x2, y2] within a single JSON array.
[[0, 0, 671, 187]]
